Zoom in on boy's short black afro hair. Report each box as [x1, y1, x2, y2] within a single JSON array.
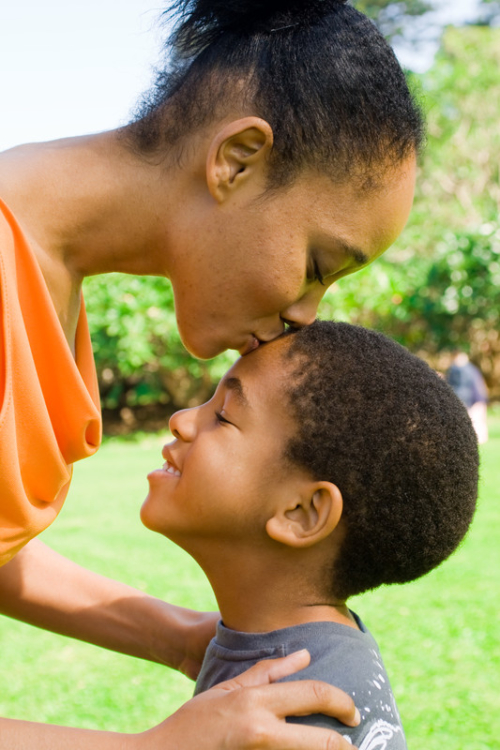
[[285, 321, 479, 599]]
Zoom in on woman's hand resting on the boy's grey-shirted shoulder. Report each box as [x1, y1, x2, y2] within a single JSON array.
[[141, 651, 359, 750]]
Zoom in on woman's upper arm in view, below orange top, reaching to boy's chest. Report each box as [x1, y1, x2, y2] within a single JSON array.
[[0, 539, 218, 678]]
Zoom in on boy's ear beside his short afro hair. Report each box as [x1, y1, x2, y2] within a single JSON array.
[[266, 482, 343, 547]]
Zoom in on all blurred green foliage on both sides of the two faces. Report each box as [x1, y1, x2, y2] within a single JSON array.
[[85, 27, 500, 418]]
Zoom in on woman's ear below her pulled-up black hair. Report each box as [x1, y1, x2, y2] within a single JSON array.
[[206, 117, 273, 203]]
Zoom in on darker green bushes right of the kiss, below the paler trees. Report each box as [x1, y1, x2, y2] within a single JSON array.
[[320, 223, 500, 398]]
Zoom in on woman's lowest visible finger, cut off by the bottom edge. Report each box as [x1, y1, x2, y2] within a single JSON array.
[[249, 724, 356, 750]]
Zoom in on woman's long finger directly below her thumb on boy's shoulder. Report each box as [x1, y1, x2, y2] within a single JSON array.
[[260, 680, 360, 727]]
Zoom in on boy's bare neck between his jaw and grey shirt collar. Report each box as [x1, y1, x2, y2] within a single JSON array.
[[197, 550, 358, 633]]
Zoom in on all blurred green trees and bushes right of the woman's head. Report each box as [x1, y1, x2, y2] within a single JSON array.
[[320, 27, 500, 398]]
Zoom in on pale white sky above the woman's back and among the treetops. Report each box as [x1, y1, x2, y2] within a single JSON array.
[[0, 0, 484, 150]]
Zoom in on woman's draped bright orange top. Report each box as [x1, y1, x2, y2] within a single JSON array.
[[0, 201, 101, 565]]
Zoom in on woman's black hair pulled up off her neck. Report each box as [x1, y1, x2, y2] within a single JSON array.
[[127, 0, 423, 187]]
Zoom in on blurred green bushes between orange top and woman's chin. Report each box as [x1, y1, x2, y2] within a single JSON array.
[[85, 274, 235, 410]]
